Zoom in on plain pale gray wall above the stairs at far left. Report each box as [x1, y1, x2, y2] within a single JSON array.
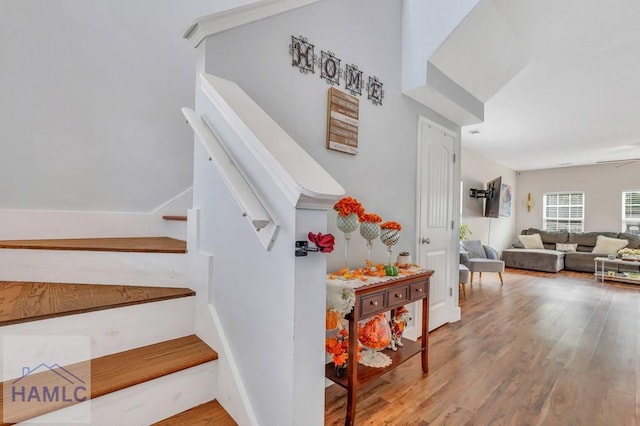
[[0, 0, 258, 212]]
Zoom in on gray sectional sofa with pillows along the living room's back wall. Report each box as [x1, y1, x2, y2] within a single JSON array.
[[502, 228, 640, 272]]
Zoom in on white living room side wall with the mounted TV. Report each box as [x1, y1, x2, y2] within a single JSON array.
[[460, 149, 524, 252]]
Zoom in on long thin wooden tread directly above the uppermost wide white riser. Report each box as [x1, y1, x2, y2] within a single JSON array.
[[0, 237, 187, 253]]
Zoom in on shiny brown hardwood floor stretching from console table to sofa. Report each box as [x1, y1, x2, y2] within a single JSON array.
[[325, 269, 640, 426]]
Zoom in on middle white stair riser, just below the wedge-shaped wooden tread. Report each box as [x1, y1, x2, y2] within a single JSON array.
[[0, 296, 195, 380]]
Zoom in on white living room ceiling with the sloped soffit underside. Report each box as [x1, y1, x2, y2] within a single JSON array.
[[429, 0, 640, 170]]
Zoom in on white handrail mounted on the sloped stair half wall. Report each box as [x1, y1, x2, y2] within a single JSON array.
[[181, 108, 279, 250]]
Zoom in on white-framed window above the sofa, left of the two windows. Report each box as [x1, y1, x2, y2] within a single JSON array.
[[543, 192, 584, 232]]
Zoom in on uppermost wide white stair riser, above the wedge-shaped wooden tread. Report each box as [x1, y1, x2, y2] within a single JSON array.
[[0, 249, 188, 287]]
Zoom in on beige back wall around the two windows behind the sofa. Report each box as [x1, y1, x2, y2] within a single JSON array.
[[516, 163, 640, 233]]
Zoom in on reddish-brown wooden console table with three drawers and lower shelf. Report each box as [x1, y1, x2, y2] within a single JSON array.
[[325, 270, 433, 426]]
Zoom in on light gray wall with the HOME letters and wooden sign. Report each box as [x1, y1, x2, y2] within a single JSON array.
[[206, 0, 459, 270]]
